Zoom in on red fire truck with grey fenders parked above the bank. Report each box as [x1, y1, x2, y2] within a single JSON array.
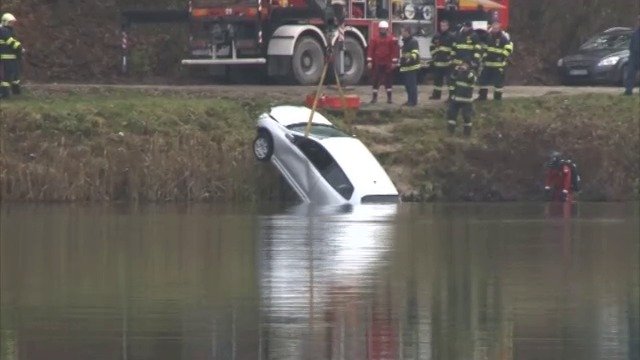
[[182, 0, 509, 85]]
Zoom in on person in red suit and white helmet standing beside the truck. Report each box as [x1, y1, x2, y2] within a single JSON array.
[[367, 21, 400, 104]]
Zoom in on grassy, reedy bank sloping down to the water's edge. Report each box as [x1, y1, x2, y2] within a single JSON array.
[[0, 90, 640, 201]]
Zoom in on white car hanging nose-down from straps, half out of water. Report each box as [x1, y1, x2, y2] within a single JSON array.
[[253, 106, 399, 205]]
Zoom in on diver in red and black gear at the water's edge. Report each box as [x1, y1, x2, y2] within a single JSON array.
[[544, 151, 581, 202]]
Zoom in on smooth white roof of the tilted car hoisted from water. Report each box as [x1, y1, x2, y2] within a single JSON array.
[[319, 137, 398, 197]]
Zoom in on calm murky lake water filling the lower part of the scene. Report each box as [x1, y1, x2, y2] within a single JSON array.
[[0, 204, 640, 359]]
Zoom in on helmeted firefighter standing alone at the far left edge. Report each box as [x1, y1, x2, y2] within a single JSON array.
[[0, 13, 24, 97]]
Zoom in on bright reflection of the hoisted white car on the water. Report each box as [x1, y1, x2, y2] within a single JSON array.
[[260, 204, 397, 359]]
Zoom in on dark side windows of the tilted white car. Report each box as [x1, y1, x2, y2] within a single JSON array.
[[294, 136, 353, 200]]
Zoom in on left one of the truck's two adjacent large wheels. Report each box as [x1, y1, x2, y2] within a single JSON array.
[[291, 36, 324, 85]]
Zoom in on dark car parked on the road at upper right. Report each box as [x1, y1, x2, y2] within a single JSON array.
[[558, 27, 632, 85]]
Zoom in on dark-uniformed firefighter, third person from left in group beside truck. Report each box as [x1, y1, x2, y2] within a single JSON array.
[[429, 20, 454, 100]]
